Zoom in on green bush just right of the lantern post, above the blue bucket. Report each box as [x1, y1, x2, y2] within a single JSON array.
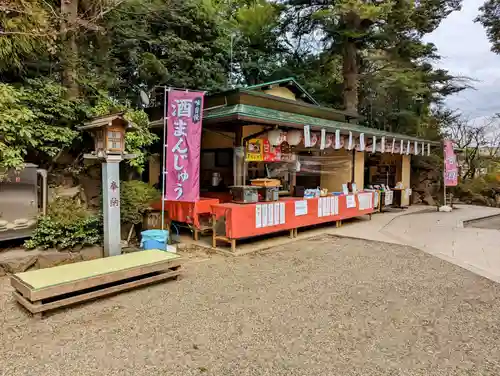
[[120, 180, 161, 224]]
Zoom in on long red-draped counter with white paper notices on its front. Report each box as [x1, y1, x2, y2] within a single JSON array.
[[212, 192, 375, 251]]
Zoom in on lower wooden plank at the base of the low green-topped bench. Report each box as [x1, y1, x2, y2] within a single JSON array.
[[13, 269, 181, 314]]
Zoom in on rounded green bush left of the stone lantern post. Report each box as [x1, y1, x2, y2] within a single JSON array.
[[25, 197, 102, 249]]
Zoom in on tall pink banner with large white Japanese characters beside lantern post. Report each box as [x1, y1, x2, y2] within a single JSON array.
[[165, 90, 204, 202]]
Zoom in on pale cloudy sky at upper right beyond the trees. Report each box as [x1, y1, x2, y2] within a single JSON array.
[[426, 0, 500, 120]]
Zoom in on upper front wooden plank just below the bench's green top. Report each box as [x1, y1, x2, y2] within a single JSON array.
[[13, 256, 181, 302]]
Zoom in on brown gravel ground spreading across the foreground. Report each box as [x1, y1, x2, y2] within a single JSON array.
[[0, 237, 500, 376]]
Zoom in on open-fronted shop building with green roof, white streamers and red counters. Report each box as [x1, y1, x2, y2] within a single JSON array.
[[145, 78, 438, 252]]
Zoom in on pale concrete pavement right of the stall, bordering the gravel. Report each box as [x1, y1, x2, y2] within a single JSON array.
[[331, 205, 500, 282]]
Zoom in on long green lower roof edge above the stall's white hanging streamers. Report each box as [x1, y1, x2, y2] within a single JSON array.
[[203, 104, 440, 145]]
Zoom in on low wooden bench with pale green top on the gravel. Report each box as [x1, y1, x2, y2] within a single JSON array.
[[10, 250, 181, 317]]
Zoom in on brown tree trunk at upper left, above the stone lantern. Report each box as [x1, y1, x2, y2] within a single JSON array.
[[61, 0, 78, 99]]
